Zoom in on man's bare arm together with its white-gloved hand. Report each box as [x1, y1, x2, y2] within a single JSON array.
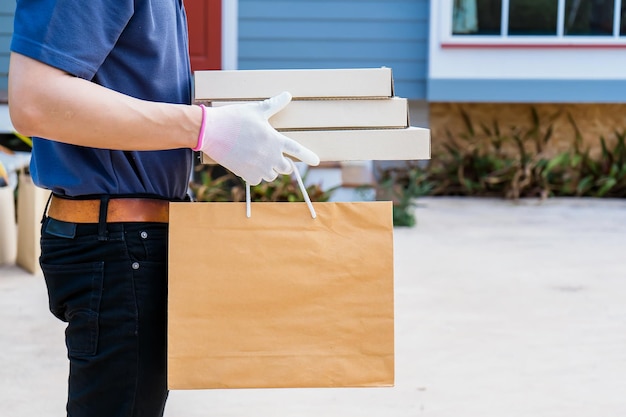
[[9, 53, 319, 185]]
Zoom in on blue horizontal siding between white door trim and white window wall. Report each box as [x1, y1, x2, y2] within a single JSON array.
[[238, 0, 429, 99]]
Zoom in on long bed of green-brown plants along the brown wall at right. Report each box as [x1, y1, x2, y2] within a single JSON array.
[[377, 108, 626, 226]]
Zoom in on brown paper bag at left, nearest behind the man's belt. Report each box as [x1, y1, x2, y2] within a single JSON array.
[[16, 172, 50, 274]]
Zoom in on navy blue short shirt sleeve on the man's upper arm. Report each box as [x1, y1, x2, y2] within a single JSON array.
[[11, 0, 133, 80]]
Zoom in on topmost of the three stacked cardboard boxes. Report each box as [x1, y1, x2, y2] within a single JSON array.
[[194, 68, 394, 101]]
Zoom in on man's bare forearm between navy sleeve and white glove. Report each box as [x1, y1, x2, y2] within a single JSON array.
[[9, 53, 202, 150]]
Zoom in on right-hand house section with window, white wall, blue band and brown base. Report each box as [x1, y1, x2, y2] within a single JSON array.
[[426, 0, 626, 154]]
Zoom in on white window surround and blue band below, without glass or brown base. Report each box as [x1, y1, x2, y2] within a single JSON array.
[[427, 0, 626, 103]]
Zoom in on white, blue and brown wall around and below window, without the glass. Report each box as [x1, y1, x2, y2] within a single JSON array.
[[427, 0, 626, 154]]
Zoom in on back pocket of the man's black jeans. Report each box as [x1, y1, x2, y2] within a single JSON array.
[[41, 262, 104, 356]]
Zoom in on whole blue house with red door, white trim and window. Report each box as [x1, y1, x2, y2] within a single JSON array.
[[0, 0, 626, 156]]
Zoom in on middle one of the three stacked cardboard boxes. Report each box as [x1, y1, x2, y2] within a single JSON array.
[[211, 97, 409, 130]]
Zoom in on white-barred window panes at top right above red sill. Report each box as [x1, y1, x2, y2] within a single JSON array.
[[448, 0, 626, 42]]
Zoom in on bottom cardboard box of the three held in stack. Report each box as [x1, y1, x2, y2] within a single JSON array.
[[202, 126, 430, 164]]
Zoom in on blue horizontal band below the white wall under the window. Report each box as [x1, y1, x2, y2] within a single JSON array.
[[428, 79, 626, 103]]
